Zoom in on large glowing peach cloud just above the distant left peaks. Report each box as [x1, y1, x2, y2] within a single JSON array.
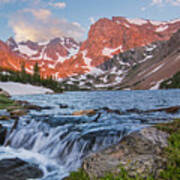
[[9, 9, 85, 42]]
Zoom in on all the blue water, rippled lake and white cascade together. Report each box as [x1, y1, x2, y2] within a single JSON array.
[[0, 90, 180, 180]]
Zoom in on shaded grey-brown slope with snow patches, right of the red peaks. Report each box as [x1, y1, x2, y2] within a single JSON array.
[[62, 29, 180, 90]]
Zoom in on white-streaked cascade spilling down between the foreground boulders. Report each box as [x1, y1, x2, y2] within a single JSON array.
[[5, 114, 129, 179]]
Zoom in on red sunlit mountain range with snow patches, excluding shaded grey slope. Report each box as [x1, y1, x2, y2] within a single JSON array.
[[0, 17, 180, 82]]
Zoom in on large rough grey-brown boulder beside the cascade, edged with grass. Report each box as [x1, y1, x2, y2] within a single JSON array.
[[82, 128, 169, 180]]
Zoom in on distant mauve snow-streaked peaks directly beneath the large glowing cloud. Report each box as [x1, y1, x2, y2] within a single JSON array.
[[6, 37, 79, 62]]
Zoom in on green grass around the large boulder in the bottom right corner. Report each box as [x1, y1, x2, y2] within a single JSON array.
[[66, 119, 180, 180]]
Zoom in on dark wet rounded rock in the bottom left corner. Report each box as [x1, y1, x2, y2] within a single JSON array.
[[0, 158, 43, 180]]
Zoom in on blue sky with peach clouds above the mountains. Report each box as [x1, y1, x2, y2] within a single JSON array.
[[0, 0, 180, 42]]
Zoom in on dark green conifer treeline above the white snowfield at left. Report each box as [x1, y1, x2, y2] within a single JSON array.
[[0, 63, 63, 93]]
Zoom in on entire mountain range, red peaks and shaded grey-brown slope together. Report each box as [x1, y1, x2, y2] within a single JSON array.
[[0, 17, 180, 90]]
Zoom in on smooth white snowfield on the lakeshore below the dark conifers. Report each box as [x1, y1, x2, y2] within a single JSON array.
[[0, 82, 53, 96]]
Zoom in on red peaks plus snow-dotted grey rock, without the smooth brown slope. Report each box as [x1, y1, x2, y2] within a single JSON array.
[[0, 17, 180, 89]]
